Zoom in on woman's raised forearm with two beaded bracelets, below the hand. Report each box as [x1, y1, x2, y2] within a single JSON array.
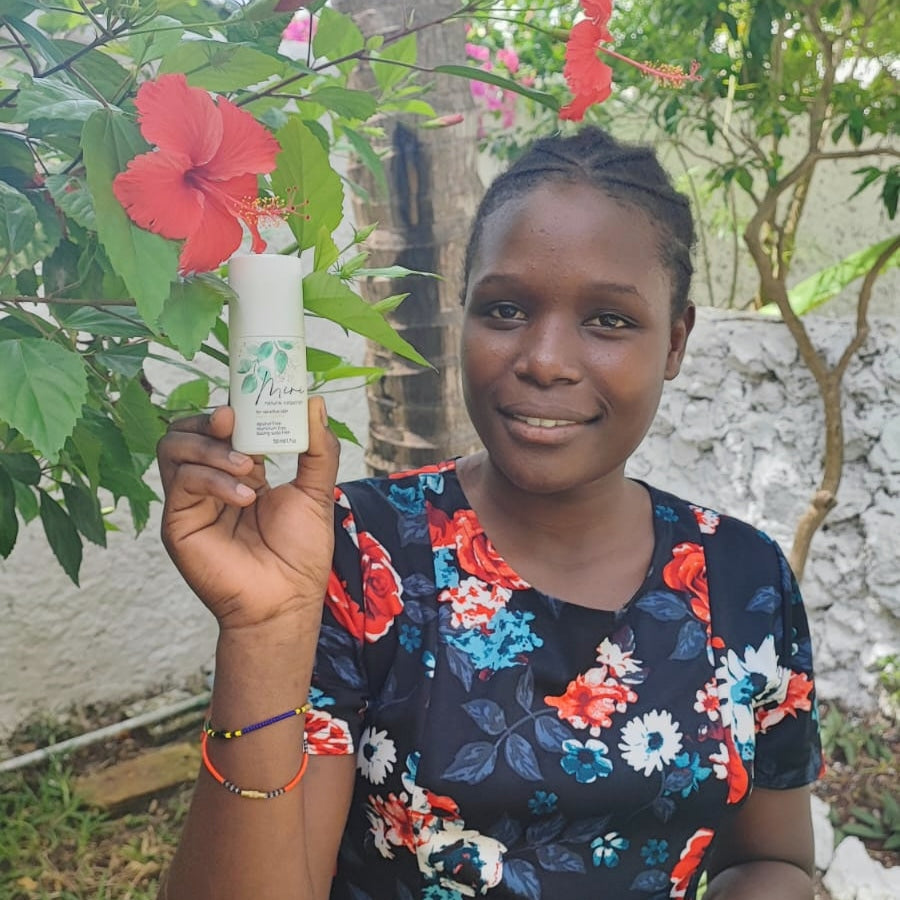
[[161, 620, 332, 900]]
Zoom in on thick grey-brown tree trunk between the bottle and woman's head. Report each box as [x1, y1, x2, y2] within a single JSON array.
[[334, 0, 482, 475]]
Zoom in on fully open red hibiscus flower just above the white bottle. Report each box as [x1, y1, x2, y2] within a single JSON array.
[[113, 75, 280, 274]]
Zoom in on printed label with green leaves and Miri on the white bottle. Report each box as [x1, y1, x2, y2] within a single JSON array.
[[232, 336, 307, 450]]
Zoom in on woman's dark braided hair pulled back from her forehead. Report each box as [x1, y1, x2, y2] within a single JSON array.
[[463, 127, 695, 317]]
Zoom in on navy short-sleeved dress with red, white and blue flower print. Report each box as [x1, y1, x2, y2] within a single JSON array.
[[307, 462, 821, 900]]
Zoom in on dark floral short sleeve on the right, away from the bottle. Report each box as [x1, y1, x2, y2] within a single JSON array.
[[754, 542, 822, 789]]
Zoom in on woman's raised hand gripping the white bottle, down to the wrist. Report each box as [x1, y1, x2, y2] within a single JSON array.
[[157, 397, 340, 630]]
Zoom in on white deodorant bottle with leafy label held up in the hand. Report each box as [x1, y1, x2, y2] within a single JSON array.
[[228, 253, 309, 454]]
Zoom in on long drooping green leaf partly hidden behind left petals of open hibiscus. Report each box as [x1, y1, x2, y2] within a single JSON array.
[[82, 109, 178, 325]]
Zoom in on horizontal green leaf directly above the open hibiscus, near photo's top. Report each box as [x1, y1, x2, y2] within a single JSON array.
[[160, 40, 286, 92]]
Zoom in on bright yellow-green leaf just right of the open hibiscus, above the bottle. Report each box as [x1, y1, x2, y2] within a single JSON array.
[[272, 117, 344, 250]]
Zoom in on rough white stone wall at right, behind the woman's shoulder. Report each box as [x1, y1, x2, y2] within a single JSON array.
[[630, 309, 900, 706]]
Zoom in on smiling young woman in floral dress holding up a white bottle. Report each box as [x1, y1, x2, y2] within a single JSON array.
[[159, 129, 820, 900]]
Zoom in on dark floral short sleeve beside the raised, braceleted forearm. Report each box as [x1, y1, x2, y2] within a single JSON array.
[[306, 488, 368, 755]]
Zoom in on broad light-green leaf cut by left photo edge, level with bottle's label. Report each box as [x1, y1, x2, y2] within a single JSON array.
[[0, 338, 88, 460]]
